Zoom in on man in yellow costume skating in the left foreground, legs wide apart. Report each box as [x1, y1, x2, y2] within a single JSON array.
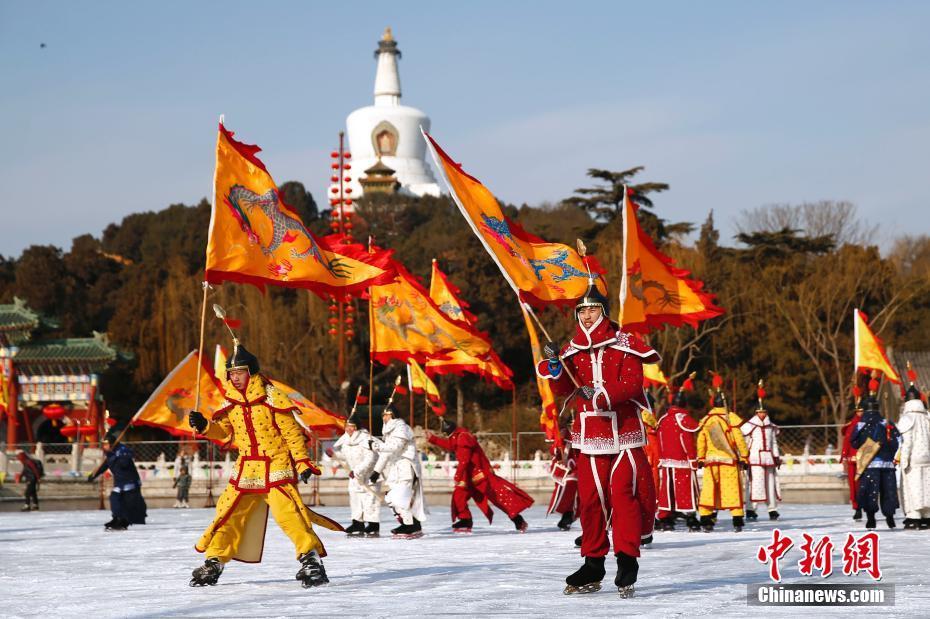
[[189, 340, 342, 587]]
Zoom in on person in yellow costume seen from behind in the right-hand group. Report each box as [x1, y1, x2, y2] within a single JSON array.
[[697, 387, 749, 533]]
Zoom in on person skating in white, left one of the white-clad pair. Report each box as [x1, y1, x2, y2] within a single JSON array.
[[327, 415, 381, 537]]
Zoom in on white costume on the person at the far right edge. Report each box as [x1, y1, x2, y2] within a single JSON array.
[[898, 399, 930, 520]]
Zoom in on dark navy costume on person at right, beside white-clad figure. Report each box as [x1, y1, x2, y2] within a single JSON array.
[[850, 398, 901, 527]]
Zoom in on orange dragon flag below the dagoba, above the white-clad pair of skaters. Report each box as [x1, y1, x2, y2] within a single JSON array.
[[369, 252, 491, 365]]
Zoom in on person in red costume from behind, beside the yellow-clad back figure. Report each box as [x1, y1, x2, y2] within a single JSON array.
[[656, 378, 701, 531]]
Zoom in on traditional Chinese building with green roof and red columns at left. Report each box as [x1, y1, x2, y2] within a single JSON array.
[[0, 299, 117, 449]]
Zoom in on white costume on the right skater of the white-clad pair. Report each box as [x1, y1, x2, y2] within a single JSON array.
[[374, 418, 427, 524]]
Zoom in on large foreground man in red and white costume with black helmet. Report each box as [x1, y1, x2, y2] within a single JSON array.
[[537, 282, 659, 598]]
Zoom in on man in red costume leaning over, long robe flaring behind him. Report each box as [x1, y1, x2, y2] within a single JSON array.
[[426, 417, 533, 533]]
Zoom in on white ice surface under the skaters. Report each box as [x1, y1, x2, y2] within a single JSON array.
[[0, 505, 930, 619]]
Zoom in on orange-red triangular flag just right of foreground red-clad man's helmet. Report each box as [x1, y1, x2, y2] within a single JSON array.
[[619, 190, 724, 333]]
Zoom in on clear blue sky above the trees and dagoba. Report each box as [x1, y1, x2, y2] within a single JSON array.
[[0, 0, 930, 256]]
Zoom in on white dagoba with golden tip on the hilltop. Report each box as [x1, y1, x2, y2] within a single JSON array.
[[346, 28, 440, 197]]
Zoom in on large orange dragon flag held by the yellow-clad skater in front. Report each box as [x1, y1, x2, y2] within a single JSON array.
[[205, 121, 394, 298]]
